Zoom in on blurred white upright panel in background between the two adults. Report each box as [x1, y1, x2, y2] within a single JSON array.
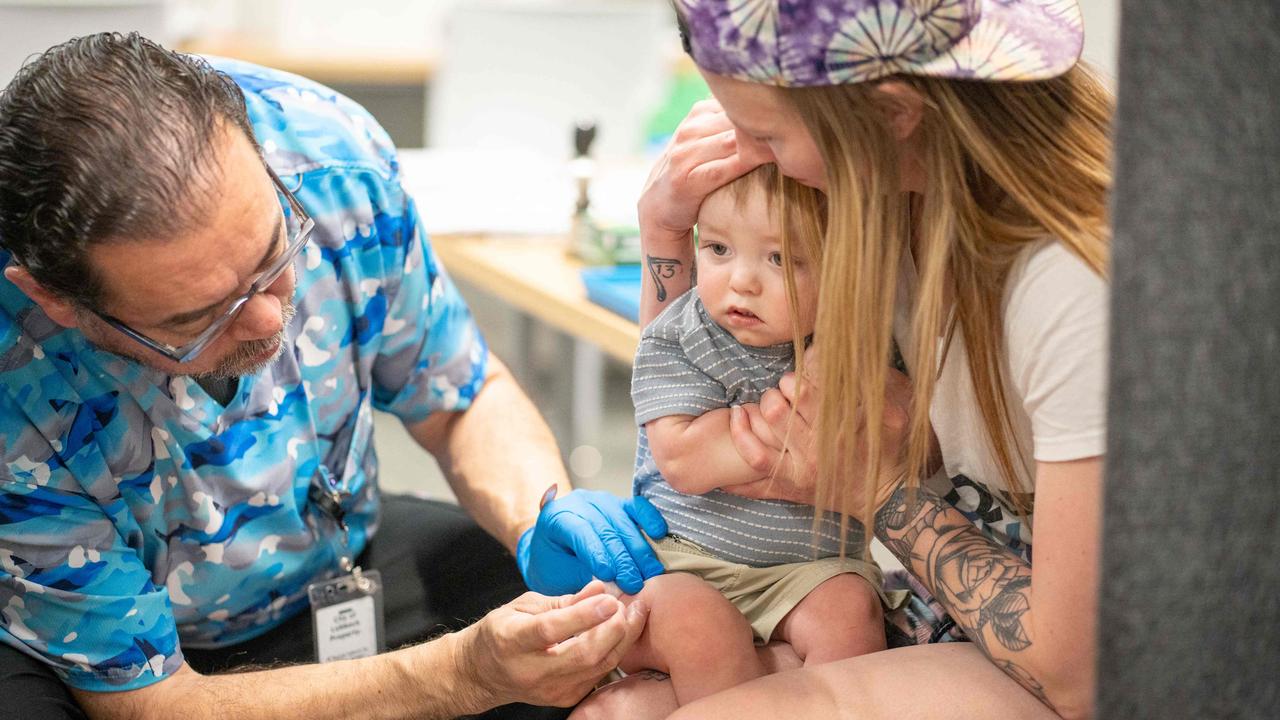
[[426, 0, 680, 159]]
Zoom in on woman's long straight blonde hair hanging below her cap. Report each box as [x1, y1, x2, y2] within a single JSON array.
[[781, 67, 1112, 538]]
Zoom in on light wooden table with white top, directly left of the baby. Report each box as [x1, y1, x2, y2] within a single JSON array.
[[431, 234, 640, 365]]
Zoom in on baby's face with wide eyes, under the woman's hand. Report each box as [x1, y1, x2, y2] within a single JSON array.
[[698, 181, 818, 347]]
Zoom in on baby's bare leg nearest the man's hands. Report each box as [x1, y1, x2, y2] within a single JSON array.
[[621, 573, 764, 705]]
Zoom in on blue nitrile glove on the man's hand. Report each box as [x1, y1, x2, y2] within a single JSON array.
[[516, 489, 667, 594]]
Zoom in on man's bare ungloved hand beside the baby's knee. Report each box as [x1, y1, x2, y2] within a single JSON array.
[[456, 582, 649, 707]]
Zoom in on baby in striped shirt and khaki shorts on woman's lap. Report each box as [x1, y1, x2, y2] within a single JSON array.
[[622, 165, 887, 705]]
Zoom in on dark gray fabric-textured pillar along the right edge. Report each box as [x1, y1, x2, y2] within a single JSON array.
[[1098, 0, 1280, 720]]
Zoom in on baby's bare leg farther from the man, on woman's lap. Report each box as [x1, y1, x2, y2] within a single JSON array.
[[776, 573, 886, 667]]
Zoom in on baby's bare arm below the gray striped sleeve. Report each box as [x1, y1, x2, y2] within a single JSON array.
[[645, 407, 768, 495]]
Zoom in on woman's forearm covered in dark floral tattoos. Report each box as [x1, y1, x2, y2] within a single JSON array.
[[876, 486, 1092, 717]]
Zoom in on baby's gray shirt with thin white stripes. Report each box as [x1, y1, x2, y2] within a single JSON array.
[[631, 290, 861, 568]]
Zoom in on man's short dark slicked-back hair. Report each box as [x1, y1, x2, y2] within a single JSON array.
[[0, 33, 253, 307]]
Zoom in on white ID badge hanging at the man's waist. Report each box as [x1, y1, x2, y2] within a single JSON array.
[[307, 568, 387, 662]]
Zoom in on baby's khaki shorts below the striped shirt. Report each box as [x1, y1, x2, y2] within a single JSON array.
[[649, 536, 906, 643]]
